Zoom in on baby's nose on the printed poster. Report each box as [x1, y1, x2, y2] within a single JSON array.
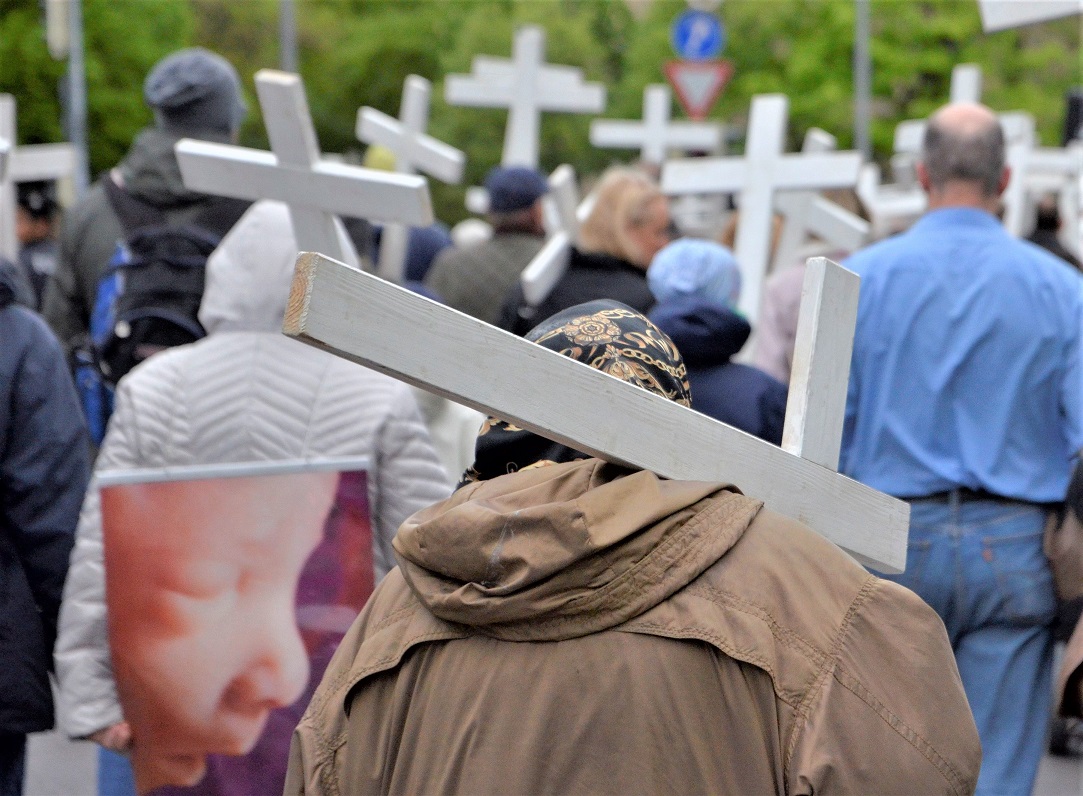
[[223, 627, 309, 713]]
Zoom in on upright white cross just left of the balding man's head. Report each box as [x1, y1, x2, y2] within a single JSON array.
[[662, 94, 861, 326]]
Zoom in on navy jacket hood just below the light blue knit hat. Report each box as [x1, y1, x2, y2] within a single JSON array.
[[648, 296, 752, 368]]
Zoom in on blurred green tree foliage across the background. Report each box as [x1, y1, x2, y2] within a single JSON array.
[[0, 0, 1083, 222]]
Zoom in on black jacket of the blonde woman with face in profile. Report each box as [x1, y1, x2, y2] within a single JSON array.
[[497, 249, 654, 337]]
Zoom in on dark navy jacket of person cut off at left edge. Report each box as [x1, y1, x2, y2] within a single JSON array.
[[0, 272, 90, 733]]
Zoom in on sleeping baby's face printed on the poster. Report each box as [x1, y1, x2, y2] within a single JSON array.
[[102, 472, 339, 793]]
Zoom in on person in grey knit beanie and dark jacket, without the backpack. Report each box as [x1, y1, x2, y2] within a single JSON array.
[[42, 48, 245, 352]]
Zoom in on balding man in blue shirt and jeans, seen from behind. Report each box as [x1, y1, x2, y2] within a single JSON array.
[[840, 104, 1083, 796]]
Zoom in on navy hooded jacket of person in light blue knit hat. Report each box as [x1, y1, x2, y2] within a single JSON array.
[[650, 297, 787, 445]]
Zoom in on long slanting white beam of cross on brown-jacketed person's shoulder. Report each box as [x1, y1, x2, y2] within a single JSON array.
[[284, 255, 910, 572]]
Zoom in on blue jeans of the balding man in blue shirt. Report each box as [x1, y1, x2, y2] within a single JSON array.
[[888, 497, 1057, 796]]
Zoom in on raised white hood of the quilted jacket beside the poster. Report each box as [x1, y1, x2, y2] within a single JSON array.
[[199, 201, 297, 335]]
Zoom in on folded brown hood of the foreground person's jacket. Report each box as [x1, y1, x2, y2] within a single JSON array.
[[393, 459, 762, 641]]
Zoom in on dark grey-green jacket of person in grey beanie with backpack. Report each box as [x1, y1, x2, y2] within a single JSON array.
[[41, 128, 237, 350]]
